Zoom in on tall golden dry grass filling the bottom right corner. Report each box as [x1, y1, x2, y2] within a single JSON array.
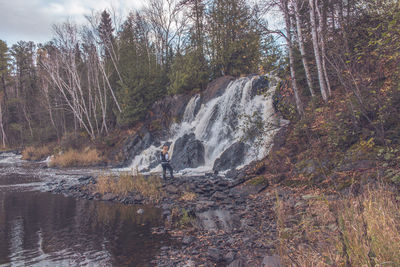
[[340, 187, 400, 266]]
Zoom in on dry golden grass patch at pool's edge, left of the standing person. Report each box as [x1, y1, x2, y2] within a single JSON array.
[[95, 173, 164, 202]]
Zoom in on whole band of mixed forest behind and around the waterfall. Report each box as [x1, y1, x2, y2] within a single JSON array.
[[0, 0, 400, 155]]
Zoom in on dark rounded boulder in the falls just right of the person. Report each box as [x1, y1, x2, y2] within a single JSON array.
[[171, 133, 204, 170]]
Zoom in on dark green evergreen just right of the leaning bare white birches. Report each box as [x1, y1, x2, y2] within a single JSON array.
[[117, 14, 166, 127]]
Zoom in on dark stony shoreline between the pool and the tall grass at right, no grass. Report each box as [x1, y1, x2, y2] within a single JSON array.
[[47, 173, 281, 267]]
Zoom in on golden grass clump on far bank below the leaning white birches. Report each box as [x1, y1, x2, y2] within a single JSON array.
[[50, 148, 103, 167]]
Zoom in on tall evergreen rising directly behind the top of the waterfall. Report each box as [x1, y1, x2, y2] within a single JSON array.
[[208, 0, 260, 77]]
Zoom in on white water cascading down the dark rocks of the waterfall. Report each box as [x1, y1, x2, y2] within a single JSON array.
[[127, 76, 279, 176]]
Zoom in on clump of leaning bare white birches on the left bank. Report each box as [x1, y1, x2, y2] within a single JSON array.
[[41, 22, 119, 138]]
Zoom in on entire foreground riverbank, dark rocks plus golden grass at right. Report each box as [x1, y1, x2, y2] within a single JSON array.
[[43, 162, 400, 267]]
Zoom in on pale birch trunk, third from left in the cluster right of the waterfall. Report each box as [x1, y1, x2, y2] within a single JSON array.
[[308, 0, 328, 101]]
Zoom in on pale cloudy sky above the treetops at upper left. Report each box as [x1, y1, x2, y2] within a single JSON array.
[[0, 0, 146, 47]]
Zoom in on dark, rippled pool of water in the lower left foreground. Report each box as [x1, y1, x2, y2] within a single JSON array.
[[0, 192, 169, 266]]
